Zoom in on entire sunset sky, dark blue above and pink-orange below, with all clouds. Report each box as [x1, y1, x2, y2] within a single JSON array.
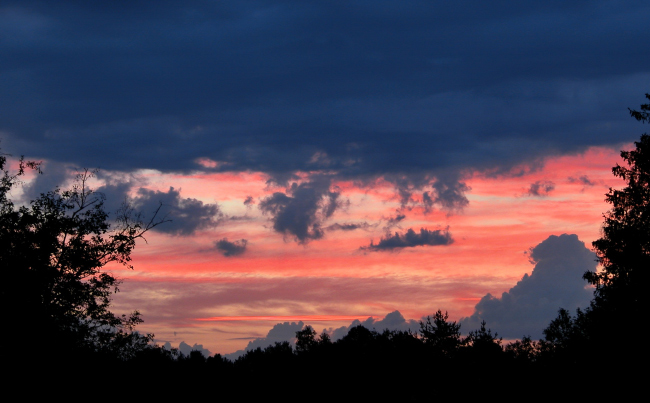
[[0, 0, 650, 354]]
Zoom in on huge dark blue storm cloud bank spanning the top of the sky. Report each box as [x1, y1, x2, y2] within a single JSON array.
[[0, 0, 650, 190]]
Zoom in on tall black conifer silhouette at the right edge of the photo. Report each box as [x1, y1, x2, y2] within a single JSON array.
[[544, 94, 650, 367]]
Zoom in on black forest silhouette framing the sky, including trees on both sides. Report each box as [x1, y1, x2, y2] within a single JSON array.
[[0, 94, 650, 385]]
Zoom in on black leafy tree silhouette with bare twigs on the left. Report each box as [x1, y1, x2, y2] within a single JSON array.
[[0, 155, 162, 359]]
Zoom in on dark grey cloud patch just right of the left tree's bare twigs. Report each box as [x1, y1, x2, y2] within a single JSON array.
[[132, 187, 223, 235]]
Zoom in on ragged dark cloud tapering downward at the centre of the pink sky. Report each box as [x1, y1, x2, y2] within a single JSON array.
[[259, 178, 343, 244]]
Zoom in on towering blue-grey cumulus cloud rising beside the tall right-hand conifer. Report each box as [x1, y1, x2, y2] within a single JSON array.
[[460, 234, 596, 338]]
